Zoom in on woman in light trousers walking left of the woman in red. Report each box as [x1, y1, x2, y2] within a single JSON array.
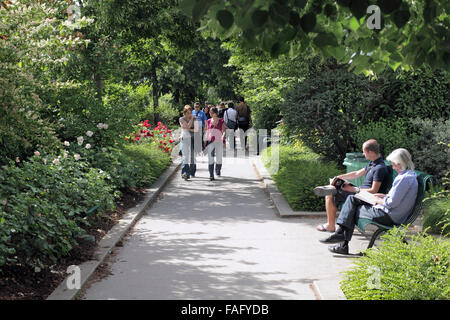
[[179, 104, 198, 180]]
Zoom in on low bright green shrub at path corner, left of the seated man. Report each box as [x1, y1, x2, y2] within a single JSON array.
[[262, 145, 341, 211]]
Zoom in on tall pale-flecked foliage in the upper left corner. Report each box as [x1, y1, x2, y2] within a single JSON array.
[[0, 0, 87, 164]]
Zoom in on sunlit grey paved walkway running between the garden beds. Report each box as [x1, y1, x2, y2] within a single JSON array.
[[83, 152, 367, 300]]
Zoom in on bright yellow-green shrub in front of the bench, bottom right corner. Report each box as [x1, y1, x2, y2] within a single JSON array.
[[341, 228, 450, 300]]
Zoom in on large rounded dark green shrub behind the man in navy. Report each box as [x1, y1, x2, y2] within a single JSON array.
[[281, 65, 383, 163]]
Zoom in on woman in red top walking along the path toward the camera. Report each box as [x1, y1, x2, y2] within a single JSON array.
[[205, 107, 228, 181]]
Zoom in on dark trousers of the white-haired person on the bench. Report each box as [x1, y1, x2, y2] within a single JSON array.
[[336, 195, 394, 241]]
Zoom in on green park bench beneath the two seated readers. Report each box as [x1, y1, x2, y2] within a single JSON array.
[[357, 170, 433, 249]]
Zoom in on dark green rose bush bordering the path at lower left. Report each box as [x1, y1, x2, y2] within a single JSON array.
[[0, 154, 114, 268]]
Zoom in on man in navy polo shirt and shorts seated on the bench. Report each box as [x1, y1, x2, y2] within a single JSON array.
[[314, 139, 389, 232]]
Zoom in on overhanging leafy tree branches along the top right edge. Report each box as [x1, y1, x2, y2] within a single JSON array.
[[180, 0, 450, 74]]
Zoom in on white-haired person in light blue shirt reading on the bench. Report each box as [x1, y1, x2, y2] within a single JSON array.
[[319, 148, 418, 254]]
